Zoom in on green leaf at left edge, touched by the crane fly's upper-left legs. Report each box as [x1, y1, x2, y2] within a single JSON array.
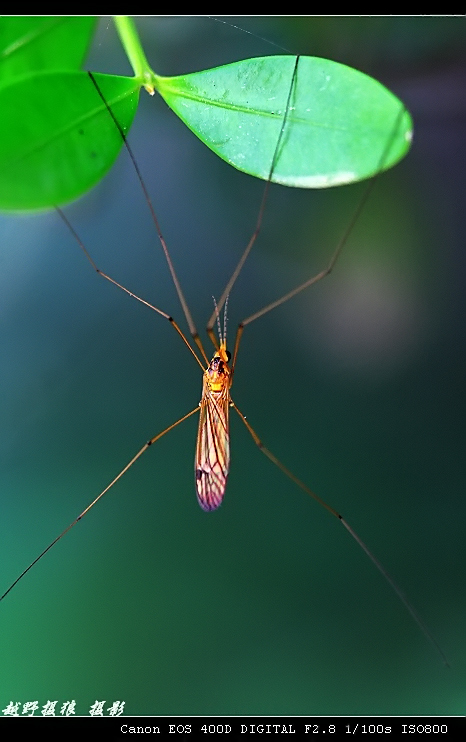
[[0, 72, 140, 211]]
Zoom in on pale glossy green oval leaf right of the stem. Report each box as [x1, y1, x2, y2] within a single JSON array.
[[156, 56, 412, 188]]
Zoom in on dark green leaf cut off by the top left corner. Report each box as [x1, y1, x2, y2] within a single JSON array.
[[0, 16, 96, 83]]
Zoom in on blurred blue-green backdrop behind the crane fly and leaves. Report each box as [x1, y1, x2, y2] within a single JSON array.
[[0, 17, 466, 715]]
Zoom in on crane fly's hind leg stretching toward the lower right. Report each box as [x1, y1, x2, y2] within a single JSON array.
[[230, 400, 450, 667]]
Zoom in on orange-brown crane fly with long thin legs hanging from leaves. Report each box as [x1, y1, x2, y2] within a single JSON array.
[[0, 49, 448, 664]]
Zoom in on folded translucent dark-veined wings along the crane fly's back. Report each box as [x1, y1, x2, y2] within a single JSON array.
[[194, 389, 230, 510]]
